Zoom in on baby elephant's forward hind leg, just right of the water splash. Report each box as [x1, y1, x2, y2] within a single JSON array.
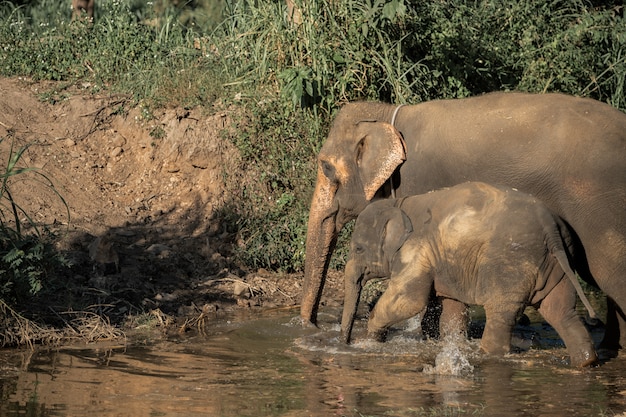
[[480, 303, 524, 356]]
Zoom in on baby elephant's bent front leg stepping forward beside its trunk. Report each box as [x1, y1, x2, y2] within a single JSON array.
[[367, 279, 430, 342]]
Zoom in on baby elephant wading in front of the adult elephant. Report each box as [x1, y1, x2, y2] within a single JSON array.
[[341, 183, 597, 366]]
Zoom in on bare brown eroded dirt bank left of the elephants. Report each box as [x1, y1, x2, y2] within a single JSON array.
[[0, 79, 340, 342]]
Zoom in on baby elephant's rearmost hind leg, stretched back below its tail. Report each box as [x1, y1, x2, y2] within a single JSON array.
[[538, 279, 598, 367]]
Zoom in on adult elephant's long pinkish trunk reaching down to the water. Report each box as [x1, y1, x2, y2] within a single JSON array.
[[300, 170, 338, 325]]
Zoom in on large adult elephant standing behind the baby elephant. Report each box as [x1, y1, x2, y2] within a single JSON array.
[[300, 93, 626, 349]]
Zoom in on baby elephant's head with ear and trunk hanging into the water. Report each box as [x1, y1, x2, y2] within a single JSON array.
[[341, 204, 413, 343]]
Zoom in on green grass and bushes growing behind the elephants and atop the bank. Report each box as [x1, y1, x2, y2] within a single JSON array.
[[0, 0, 626, 282]]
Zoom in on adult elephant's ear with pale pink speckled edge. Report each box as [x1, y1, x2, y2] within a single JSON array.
[[356, 121, 406, 201]]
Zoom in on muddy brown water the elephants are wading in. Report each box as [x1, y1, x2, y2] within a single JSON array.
[[0, 311, 626, 417]]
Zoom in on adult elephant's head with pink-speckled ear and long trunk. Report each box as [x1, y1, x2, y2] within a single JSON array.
[[300, 104, 406, 324]]
